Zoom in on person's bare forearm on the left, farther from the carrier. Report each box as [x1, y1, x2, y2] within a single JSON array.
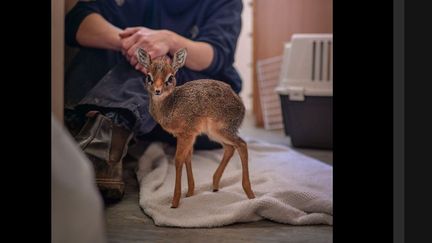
[[76, 13, 122, 51]]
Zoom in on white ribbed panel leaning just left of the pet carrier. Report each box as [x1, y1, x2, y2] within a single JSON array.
[[257, 56, 283, 130]]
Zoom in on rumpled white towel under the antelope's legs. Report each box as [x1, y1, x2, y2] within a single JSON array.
[[137, 140, 333, 227]]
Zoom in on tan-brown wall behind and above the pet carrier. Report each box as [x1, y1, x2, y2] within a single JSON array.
[[252, 0, 333, 126]]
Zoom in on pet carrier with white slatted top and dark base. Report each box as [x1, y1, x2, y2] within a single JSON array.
[[275, 34, 333, 149]]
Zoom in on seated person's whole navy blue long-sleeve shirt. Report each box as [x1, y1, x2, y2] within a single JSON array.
[[65, 0, 243, 93]]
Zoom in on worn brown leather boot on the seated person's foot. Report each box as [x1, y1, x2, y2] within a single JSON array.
[[75, 111, 132, 201]]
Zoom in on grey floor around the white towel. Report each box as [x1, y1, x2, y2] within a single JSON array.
[[105, 111, 333, 243]]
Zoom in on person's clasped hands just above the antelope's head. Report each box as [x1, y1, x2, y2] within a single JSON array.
[[119, 27, 172, 72]]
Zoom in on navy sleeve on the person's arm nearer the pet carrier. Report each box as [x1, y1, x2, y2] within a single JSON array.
[[195, 0, 243, 75]]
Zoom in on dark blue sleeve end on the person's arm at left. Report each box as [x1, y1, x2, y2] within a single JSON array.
[[65, 1, 101, 46]]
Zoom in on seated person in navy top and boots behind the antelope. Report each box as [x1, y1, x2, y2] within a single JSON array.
[[65, 0, 243, 200]]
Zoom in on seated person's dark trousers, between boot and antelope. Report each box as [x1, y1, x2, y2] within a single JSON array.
[[65, 49, 222, 149]]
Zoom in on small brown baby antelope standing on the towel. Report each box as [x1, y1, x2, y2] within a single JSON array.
[[137, 48, 255, 208]]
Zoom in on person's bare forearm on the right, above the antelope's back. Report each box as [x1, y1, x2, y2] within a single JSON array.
[[170, 32, 214, 71]]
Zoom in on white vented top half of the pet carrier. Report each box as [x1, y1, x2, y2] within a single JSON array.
[[276, 34, 333, 101]]
